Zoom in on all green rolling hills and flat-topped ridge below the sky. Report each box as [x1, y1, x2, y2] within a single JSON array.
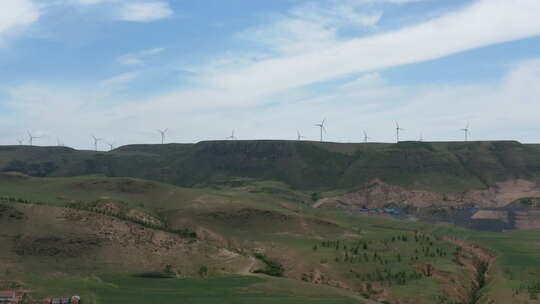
[[0, 141, 540, 304]]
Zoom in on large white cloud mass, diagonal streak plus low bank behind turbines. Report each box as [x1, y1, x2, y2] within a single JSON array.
[[0, 0, 540, 147]]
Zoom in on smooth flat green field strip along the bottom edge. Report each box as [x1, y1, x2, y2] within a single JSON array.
[[22, 274, 358, 304]]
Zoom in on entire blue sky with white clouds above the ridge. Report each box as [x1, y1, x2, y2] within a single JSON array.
[[0, 0, 540, 150]]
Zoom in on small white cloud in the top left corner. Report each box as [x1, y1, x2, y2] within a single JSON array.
[[0, 0, 40, 39]]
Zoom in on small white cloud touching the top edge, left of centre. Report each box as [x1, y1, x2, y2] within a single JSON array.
[[120, 1, 174, 22]]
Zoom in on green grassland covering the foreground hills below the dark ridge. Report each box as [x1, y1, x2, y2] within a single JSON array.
[[0, 173, 540, 304]]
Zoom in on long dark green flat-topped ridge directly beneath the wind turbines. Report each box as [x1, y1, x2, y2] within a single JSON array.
[[0, 140, 540, 192]]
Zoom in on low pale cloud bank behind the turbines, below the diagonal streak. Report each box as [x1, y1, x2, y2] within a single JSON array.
[[4, 59, 540, 147]]
